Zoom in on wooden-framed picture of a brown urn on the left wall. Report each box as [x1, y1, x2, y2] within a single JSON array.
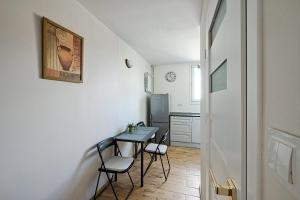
[[42, 17, 83, 83]]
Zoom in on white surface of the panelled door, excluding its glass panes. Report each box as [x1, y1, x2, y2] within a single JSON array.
[[208, 0, 246, 200]]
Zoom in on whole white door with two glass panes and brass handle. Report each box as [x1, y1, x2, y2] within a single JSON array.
[[208, 0, 246, 200]]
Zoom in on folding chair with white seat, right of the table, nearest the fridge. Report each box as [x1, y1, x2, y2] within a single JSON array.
[[144, 130, 171, 180]]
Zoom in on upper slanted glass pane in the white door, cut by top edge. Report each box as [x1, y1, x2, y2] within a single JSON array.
[[209, 0, 226, 46]]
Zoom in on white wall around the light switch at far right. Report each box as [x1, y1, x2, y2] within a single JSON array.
[[262, 0, 300, 200]]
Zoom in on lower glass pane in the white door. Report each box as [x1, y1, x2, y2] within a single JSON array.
[[210, 60, 227, 93]]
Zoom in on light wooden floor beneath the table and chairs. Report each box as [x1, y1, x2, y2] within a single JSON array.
[[97, 147, 200, 200]]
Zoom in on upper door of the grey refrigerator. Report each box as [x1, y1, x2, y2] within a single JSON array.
[[150, 94, 169, 122]]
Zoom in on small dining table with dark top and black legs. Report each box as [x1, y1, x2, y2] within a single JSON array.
[[114, 127, 159, 187]]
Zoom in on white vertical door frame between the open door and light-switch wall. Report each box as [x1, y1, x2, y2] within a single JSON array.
[[246, 0, 263, 200]]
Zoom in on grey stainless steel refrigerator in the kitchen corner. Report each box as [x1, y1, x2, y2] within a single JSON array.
[[150, 94, 170, 145]]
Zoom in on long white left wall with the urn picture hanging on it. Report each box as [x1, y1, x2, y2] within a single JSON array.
[[0, 0, 151, 200]]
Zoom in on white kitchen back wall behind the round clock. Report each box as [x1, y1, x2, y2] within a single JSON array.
[[154, 63, 200, 113]]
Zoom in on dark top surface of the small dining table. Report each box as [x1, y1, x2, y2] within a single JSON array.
[[114, 127, 159, 142]]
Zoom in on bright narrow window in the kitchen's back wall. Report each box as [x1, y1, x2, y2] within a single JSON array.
[[191, 65, 201, 103]]
